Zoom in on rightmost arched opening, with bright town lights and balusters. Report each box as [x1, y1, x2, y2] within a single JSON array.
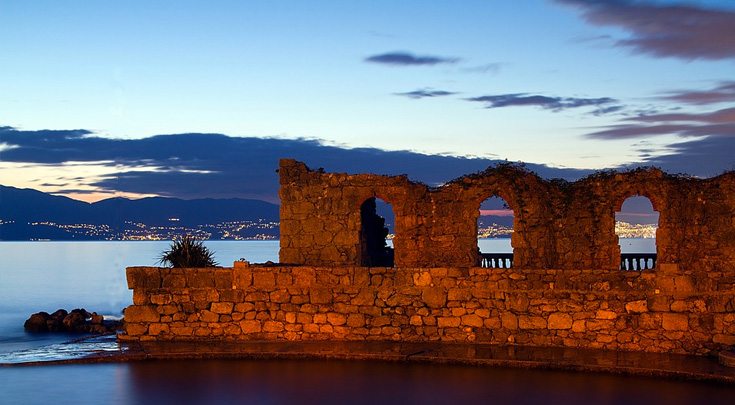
[[615, 195, 659, 270]]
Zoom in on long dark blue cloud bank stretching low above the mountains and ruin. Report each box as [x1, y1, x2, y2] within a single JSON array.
[[0, 127, 591, 201]]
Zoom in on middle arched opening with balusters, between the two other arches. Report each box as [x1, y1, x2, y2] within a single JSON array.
[[477, 196, 513, 268]]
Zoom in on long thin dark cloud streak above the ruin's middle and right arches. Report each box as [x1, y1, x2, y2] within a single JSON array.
[[467, 93, 622, 115]]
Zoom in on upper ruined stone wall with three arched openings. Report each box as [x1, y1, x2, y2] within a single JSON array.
[[280, 159, 735, 272]]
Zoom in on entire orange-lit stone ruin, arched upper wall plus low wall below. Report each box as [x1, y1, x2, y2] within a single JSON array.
[[120, 160, 735, 354]]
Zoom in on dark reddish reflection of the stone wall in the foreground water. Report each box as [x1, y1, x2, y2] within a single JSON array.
[[123, 360, 735, 405]]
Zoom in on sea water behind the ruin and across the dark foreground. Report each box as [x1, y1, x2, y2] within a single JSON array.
[[0, 239, 735, 405]]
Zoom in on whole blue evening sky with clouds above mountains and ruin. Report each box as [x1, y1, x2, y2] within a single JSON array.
[[0, 0, 735, 201]]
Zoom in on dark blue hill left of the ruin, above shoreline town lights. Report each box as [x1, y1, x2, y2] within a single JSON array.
[[0, 186, 279, 240]]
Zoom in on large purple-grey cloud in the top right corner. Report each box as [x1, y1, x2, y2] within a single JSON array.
[[556, 0, 735, 60]]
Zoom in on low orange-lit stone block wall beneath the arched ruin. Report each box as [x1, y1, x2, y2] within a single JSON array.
[[119, 263, 735, 354]]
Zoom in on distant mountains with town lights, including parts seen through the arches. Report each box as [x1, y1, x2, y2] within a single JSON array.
[[0, 186, 658, 241]]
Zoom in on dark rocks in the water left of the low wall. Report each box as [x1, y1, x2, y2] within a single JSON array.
[[23, 308, 122, 335]]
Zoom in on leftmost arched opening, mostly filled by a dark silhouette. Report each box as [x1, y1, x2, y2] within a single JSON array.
[[360, 198, 394, 267]]
